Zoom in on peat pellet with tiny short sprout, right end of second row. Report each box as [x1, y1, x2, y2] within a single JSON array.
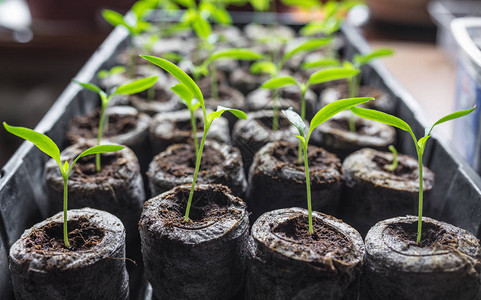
[[341, 148, 434, 236]]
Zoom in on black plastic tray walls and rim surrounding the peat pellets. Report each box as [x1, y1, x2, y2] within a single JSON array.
[[0, 13, 481, 299]]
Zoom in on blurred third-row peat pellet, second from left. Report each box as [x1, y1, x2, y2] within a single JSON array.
[[149, 109, 231, 154]]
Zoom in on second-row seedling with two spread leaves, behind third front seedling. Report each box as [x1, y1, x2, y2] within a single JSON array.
[[261, 68, 359, 163]]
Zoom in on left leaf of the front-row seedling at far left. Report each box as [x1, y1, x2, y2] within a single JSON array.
[[3, 122, 62, 168]]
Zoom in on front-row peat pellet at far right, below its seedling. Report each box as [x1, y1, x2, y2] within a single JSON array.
[[362, 216, 481, 300]]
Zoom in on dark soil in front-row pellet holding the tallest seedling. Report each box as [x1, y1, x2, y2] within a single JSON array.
[[159, 184, 240, 229]]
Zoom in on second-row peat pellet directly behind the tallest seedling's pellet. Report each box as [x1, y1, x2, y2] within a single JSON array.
[[147, 140, 247, 196]]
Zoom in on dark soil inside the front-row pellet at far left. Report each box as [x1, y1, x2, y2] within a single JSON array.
[[26, 218, 104, 255]]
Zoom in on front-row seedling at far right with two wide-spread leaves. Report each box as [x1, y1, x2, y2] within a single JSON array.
[[351, 106, 476, 243]]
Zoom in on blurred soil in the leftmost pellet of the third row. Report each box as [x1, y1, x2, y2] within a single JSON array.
[[69, 109, 138, 139]]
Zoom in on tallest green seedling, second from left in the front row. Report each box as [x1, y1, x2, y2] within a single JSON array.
[[141, 55, 247, 222]]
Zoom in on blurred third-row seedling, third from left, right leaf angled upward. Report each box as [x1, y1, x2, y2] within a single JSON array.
[[250, 38, 332, 131]]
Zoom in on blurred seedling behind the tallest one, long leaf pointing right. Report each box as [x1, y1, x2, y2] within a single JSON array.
[[193, 48, 263, 100]]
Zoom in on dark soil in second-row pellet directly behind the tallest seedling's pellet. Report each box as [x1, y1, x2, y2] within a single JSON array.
[[155, 144, 224, 177]]
